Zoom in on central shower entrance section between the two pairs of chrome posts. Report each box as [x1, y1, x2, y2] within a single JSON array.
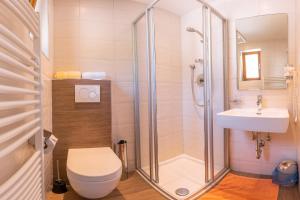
[[150, 0, 206, 198]]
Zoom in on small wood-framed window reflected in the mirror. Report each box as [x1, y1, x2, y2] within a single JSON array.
[[242, 51, 261, 81]]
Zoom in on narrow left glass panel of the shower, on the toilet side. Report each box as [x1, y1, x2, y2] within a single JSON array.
[[133, 15, 153, 179]]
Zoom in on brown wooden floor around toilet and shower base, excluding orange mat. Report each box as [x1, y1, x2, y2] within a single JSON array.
[[47, 172, 300, 200]]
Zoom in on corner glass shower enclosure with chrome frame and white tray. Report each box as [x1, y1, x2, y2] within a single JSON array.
[[133, 0, 229, 199]]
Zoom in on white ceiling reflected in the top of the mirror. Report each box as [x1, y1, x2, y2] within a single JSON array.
[[236, 14, 288, 42]]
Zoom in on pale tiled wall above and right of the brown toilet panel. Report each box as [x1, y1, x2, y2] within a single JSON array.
[[54, 0, 145, 170]]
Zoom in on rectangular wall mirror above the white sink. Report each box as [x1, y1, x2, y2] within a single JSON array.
[[236, 14, 288, 90]]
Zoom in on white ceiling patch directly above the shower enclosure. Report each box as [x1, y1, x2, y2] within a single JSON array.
[[133, 0, 201, 16]]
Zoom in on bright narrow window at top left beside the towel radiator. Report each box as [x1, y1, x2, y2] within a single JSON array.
[[35, 0, 49, 58]]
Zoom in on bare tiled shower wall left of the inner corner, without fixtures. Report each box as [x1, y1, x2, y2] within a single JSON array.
[[154, 9, 183, 161]]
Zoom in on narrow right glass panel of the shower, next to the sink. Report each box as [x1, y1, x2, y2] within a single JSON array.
[[209, 12, 228, 177]]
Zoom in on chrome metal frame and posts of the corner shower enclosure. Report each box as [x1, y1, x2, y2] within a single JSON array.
[[132, 0, 230, 199]]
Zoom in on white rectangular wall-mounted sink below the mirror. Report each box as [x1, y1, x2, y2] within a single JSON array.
[[216, 108, 289, 133]]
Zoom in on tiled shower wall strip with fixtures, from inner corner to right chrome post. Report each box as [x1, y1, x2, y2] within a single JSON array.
[[181, 7, 204, 160]]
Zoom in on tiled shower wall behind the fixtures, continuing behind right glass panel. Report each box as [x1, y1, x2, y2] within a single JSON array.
[[181, 7, 224, 172]]
